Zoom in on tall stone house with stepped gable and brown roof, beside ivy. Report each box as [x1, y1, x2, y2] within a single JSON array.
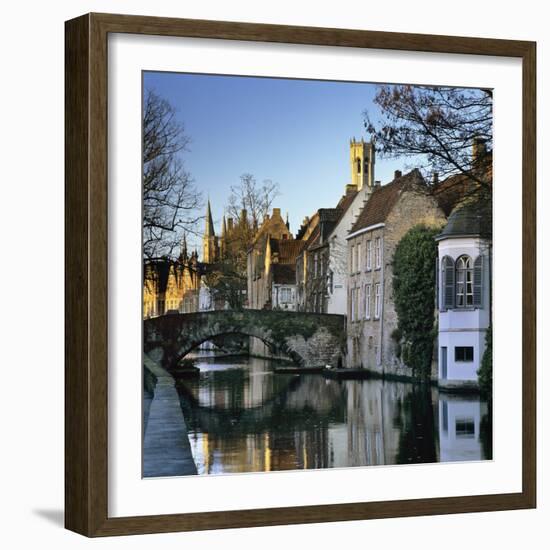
[[347, 170, 446, 376]]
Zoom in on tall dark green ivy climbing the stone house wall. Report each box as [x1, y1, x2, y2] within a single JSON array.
[[393, 225, 440, 378]]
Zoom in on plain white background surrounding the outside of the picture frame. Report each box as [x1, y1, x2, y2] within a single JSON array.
[[0, 0, 550, 550]]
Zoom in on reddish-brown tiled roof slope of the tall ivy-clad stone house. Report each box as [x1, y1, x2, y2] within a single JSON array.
[[351, 168, 426, 233]]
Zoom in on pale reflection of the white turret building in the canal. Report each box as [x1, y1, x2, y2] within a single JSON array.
[[439, 394, 487, 462]]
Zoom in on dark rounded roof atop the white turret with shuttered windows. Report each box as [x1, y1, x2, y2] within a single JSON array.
[[436, 198, 493, 241]]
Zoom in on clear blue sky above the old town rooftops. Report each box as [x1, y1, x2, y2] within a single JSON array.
[[143, 72, 405, 253]]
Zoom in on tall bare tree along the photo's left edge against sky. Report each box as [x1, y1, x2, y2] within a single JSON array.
[[143, 90, 202, 261]]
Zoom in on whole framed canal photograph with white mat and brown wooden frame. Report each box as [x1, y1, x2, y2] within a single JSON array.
[[65, 14, 536, 536]]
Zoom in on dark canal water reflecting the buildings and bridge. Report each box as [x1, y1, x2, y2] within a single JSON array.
[[176, 353, 492, 474]]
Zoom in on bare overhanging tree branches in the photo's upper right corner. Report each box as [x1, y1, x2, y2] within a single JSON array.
[[364, 85, 493, 186]]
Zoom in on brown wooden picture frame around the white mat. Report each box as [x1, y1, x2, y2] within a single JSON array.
[[65, 14, 536, 537]]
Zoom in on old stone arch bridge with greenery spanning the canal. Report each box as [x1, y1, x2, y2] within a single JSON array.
[[143, 309, 346, 369]]
